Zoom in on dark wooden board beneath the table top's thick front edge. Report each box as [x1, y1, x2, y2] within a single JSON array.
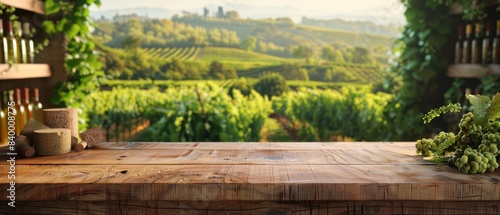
[[0, 201, 500, 215]]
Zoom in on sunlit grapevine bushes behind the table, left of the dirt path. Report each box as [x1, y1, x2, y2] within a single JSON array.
[[83, 83, 272, 142]]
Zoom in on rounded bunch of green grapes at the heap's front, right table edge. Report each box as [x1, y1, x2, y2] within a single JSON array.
[[450, 147, 498, 174]]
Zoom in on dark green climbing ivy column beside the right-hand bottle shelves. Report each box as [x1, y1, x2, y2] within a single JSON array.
[[385, 0, 500, 140]]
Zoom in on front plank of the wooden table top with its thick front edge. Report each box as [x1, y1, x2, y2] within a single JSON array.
[[0, 165, 500, 201]]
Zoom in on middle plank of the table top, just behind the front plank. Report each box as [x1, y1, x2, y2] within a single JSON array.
[[9, 148, 426, 165]]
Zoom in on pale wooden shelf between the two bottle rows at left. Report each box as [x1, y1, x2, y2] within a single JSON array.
[[0, 64, 52, 81]]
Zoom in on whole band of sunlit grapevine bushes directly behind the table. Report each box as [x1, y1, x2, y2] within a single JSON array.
[[83, 83, 392, 142]]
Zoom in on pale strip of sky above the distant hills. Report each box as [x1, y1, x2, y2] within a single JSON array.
[[94, 0, 401, 13]]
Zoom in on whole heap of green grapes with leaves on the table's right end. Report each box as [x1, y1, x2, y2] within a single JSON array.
[[415, 94, 500, 174]]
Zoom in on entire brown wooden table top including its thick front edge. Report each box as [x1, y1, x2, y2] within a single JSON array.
[[0, 142, 500, 201]]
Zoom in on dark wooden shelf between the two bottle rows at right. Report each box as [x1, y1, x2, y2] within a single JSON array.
[[447, 64, 500, 78]]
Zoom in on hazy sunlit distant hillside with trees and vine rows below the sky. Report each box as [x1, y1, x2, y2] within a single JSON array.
[[94, 15, 394, 64]]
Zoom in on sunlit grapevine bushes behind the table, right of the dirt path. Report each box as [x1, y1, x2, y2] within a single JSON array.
[[272, 88, 392, 141]]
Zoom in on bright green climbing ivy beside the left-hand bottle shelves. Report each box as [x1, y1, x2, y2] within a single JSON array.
[[42, 0, 104, 129]]
